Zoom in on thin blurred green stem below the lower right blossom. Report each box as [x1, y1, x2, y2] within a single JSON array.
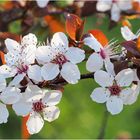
[[97, 110, 109, 139]]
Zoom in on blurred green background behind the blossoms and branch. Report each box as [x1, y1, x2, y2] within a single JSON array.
[[0, 0, 140, 139]]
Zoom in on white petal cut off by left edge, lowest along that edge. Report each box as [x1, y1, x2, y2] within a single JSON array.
[[0, 103, 9, 124]]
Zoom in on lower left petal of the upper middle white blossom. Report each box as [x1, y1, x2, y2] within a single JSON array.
[[41, 63, 60, 80]]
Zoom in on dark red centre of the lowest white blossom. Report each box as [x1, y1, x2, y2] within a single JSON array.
[[33, 100, 45, 112]]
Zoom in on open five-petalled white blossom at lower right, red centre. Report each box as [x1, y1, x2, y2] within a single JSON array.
[[91, 68, 134, 115]]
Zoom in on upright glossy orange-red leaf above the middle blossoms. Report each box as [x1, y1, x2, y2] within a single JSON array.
[[66, 14, 85, 41]]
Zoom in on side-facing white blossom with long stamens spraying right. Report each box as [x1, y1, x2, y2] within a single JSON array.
[[84, 34, 117, 75]]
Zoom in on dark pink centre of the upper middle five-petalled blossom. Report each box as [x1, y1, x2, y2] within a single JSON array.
[[52, 54, 68, 66]]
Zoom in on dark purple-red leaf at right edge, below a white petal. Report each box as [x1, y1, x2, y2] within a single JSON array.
[[122, 41, 140, 57]]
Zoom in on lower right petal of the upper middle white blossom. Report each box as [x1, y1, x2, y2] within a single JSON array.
[[61, 62, 80, 84]]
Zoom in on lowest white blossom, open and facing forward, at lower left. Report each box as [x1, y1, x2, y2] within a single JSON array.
[[13, 85, 62, 134]]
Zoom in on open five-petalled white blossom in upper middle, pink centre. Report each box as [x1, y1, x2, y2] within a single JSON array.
[[36, 32, 85, 84]]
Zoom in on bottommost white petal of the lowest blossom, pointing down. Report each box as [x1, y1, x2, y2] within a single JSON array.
[[26, 113, 44, 134]]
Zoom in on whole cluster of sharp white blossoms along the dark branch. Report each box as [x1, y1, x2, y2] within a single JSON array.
[[0, 23, 140, 134]]
